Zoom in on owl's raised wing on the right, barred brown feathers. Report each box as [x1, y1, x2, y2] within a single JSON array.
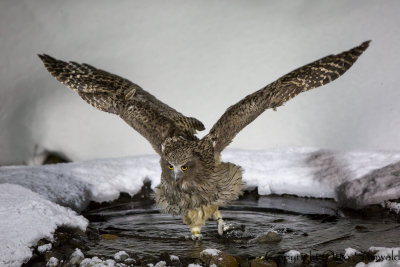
[[204, 41, 370, 152]]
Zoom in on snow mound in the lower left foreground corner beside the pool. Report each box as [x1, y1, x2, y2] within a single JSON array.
[[0, 184, 88, 266]]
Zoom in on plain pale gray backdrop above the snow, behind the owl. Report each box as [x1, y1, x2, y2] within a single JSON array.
[[0, 0, 400, 164]]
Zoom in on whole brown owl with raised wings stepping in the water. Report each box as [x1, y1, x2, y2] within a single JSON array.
[[39, 41, 369, 240]]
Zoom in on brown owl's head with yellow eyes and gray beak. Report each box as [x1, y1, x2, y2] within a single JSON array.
[[160, 137, 209, 190]]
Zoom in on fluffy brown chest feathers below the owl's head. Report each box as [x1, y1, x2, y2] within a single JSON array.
[[155, 162, 243, 215]]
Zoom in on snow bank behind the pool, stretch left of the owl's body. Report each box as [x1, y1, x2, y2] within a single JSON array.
[[0, 155, 161, 211]]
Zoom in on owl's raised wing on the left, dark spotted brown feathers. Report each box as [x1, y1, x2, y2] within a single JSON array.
[[39, 55, 204, 154]]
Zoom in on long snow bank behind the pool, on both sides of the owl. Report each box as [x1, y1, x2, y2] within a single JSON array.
[[0, 148, 400, 213]]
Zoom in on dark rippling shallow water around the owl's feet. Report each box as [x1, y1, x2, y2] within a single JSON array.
[[83, 197, 400, 258]]
